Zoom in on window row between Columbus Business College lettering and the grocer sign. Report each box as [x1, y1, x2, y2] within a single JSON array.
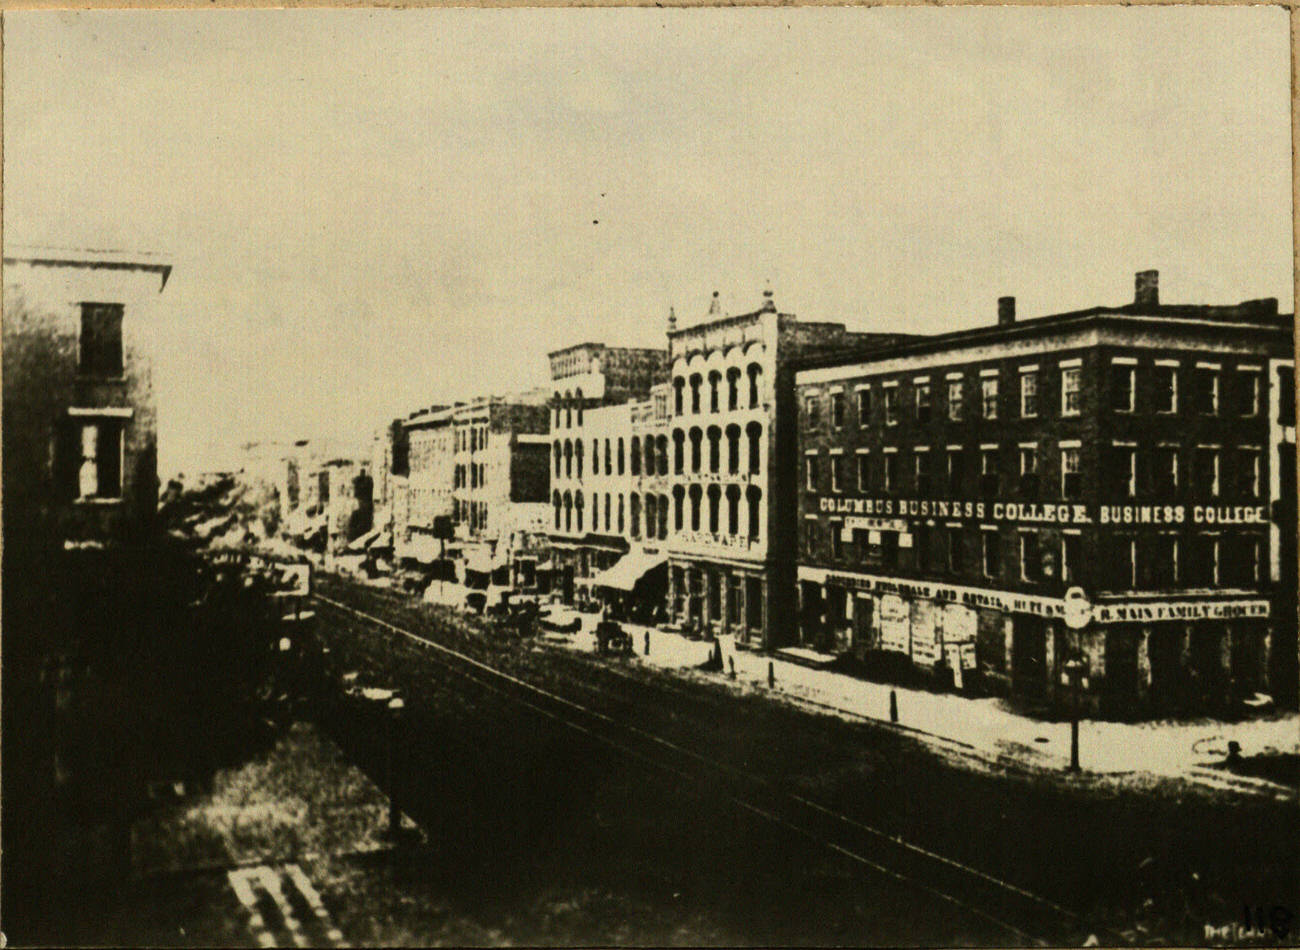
[[802, 517, 1264, 590]]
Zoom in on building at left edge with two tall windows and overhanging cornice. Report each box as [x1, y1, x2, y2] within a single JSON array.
[[3, 251, 172, 559]]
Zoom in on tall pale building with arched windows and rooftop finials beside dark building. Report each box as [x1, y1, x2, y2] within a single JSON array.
[[662, 292, 898, 648]]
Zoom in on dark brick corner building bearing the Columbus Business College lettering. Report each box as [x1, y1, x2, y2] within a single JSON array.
[[790, 272, 1296, 713]]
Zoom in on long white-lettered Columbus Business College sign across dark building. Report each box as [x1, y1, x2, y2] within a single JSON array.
[[818, 496, 1269, 530]]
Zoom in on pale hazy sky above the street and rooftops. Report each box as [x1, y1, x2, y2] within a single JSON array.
[[4, 6, 1294, 476]]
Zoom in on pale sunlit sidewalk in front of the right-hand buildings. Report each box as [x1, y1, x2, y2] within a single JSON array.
[[538, 613, 1300, 797]]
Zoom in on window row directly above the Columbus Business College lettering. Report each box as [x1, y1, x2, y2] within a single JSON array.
[[803, 442, 1264, 500]]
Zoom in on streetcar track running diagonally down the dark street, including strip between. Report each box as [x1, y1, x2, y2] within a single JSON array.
[[312, 593, 1126, 945]]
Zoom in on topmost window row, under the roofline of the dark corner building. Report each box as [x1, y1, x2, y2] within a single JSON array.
[[803, 356, 1268, 429]]
